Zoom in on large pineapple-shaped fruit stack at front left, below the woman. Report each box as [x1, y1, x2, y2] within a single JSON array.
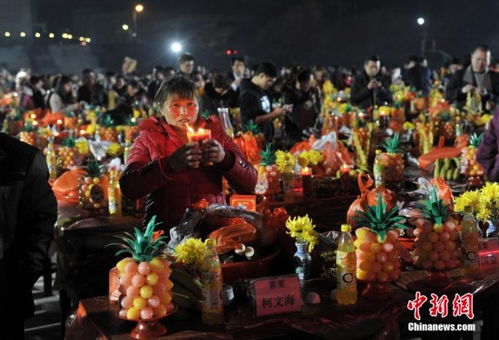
[[110, 217, 174, 320]]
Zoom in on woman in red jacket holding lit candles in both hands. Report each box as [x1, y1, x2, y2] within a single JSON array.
[[120, 77, 257, 229]]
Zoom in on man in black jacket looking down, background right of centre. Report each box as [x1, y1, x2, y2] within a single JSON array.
[[351, 56, 392, 109]]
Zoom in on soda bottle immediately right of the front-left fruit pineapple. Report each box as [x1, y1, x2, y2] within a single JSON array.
[[201, 239, 224, 325]]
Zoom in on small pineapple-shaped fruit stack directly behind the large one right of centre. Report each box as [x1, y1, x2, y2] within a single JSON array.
[[379, 133, 404, 191]]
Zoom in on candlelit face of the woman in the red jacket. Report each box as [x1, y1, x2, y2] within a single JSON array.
[[163, 95, 199, 130]]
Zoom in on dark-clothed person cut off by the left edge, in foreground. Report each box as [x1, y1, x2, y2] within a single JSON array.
[[0, 133, 57, 339]]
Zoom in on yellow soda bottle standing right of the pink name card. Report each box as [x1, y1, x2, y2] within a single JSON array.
[[336, 224, 357, 305]]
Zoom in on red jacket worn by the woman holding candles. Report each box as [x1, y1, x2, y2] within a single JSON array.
[[120, 118, 257, 229]]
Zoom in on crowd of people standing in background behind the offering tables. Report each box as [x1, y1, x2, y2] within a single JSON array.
[[0, 46, 499, 147]]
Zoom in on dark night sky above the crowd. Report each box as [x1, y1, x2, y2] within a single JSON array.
[[5, 0, 499, 71]]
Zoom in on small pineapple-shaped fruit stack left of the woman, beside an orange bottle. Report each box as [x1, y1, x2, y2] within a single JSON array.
[[79, 159, 109, 210]]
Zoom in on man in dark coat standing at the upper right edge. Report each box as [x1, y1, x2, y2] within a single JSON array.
[[446, 45, 499, 111]]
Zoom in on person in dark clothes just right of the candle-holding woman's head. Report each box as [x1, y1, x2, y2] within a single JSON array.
[[201, 74, 237, 115]]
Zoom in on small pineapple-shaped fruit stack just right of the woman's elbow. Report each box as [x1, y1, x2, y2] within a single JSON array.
[[255, 143, 281, 196]]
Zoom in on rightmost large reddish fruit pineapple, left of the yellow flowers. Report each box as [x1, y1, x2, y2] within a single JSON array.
[[412, 188, 460, 271]]
